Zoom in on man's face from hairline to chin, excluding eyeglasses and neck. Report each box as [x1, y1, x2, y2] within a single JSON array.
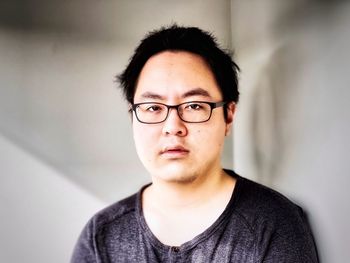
[[133, 51, 234, 182]]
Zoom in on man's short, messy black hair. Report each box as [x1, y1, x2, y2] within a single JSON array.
[[117, 24, 239, 107]]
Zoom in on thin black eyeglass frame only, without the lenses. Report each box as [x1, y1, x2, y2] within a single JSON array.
[[131, 101, 227, 124]]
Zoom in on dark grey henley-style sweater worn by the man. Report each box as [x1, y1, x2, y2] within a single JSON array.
[[71, 171, 318, 263]]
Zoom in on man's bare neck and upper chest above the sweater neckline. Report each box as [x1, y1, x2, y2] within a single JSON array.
[[142, 169, 236, 246]]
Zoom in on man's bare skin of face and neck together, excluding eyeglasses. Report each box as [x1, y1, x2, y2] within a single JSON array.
[[133, 51, 235, 248]]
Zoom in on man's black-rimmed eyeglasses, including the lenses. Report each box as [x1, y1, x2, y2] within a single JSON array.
[[132, 101, 226, 124]]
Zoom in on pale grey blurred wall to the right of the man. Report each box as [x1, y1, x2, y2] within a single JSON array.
[[232, 0, 350, 262]]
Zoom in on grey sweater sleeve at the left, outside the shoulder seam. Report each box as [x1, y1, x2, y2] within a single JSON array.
[[70, 220, 101, 263]]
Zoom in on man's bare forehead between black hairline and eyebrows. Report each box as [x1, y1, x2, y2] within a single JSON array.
[[134, 51, 221, 99]]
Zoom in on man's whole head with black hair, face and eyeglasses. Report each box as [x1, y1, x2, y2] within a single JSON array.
[[120, 26, 238, 182]]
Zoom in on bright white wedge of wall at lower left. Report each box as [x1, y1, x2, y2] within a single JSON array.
[[0, 135, 106, 263]]
